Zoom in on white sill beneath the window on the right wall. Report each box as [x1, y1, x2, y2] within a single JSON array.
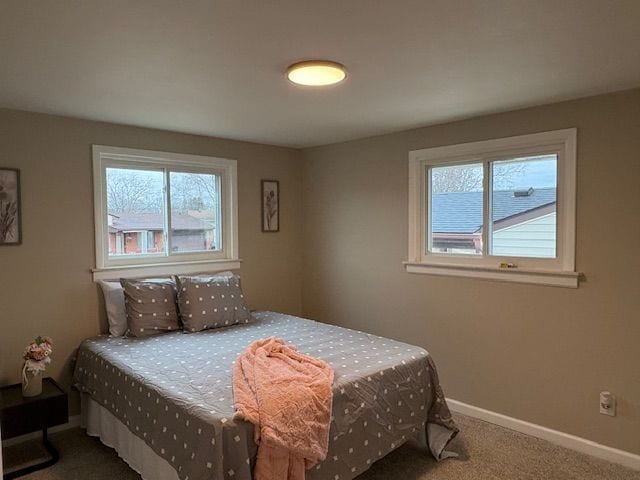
[[403, 262, 580, 288]]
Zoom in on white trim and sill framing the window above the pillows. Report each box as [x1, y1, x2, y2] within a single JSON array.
[[92, 145, 241, 281]]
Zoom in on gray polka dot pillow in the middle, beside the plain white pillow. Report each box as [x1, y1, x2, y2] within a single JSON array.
[[120, 278, 180, 337]]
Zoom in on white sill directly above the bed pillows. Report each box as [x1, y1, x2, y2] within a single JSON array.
[[91, 258, 242, 282]]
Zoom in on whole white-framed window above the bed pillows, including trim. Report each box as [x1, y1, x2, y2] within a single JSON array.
[[93, 145, 239, 279]]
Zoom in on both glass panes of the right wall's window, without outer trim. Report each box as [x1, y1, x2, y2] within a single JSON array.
[[425, 154, 557, 258]]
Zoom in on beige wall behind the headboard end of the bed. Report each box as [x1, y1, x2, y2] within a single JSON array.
[[0, 109, 302, 412]]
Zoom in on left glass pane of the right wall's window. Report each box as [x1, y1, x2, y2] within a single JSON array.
[[429, 163, 484, 255]]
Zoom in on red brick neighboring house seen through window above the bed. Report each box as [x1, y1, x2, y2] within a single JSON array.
[[109, 213, 218, 255]]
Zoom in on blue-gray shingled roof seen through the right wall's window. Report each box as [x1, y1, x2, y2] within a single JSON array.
[[431, 188, 556, 233]]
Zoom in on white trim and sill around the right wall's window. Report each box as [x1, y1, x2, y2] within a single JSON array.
[[403, 128, 579, 288]]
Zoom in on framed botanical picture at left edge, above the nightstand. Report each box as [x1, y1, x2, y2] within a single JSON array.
[[0, 167, 22, 246]]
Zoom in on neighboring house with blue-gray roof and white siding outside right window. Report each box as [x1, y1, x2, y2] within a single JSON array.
[[431, 188, 556, 257]]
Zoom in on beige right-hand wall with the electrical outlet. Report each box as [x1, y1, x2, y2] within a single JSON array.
[[303, 90, 640, 453]]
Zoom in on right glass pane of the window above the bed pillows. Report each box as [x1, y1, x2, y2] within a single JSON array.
[[169, 172, 222, 252]]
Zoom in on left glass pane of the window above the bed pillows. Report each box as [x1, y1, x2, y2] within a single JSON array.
[[106, 168, 164, 257]]
